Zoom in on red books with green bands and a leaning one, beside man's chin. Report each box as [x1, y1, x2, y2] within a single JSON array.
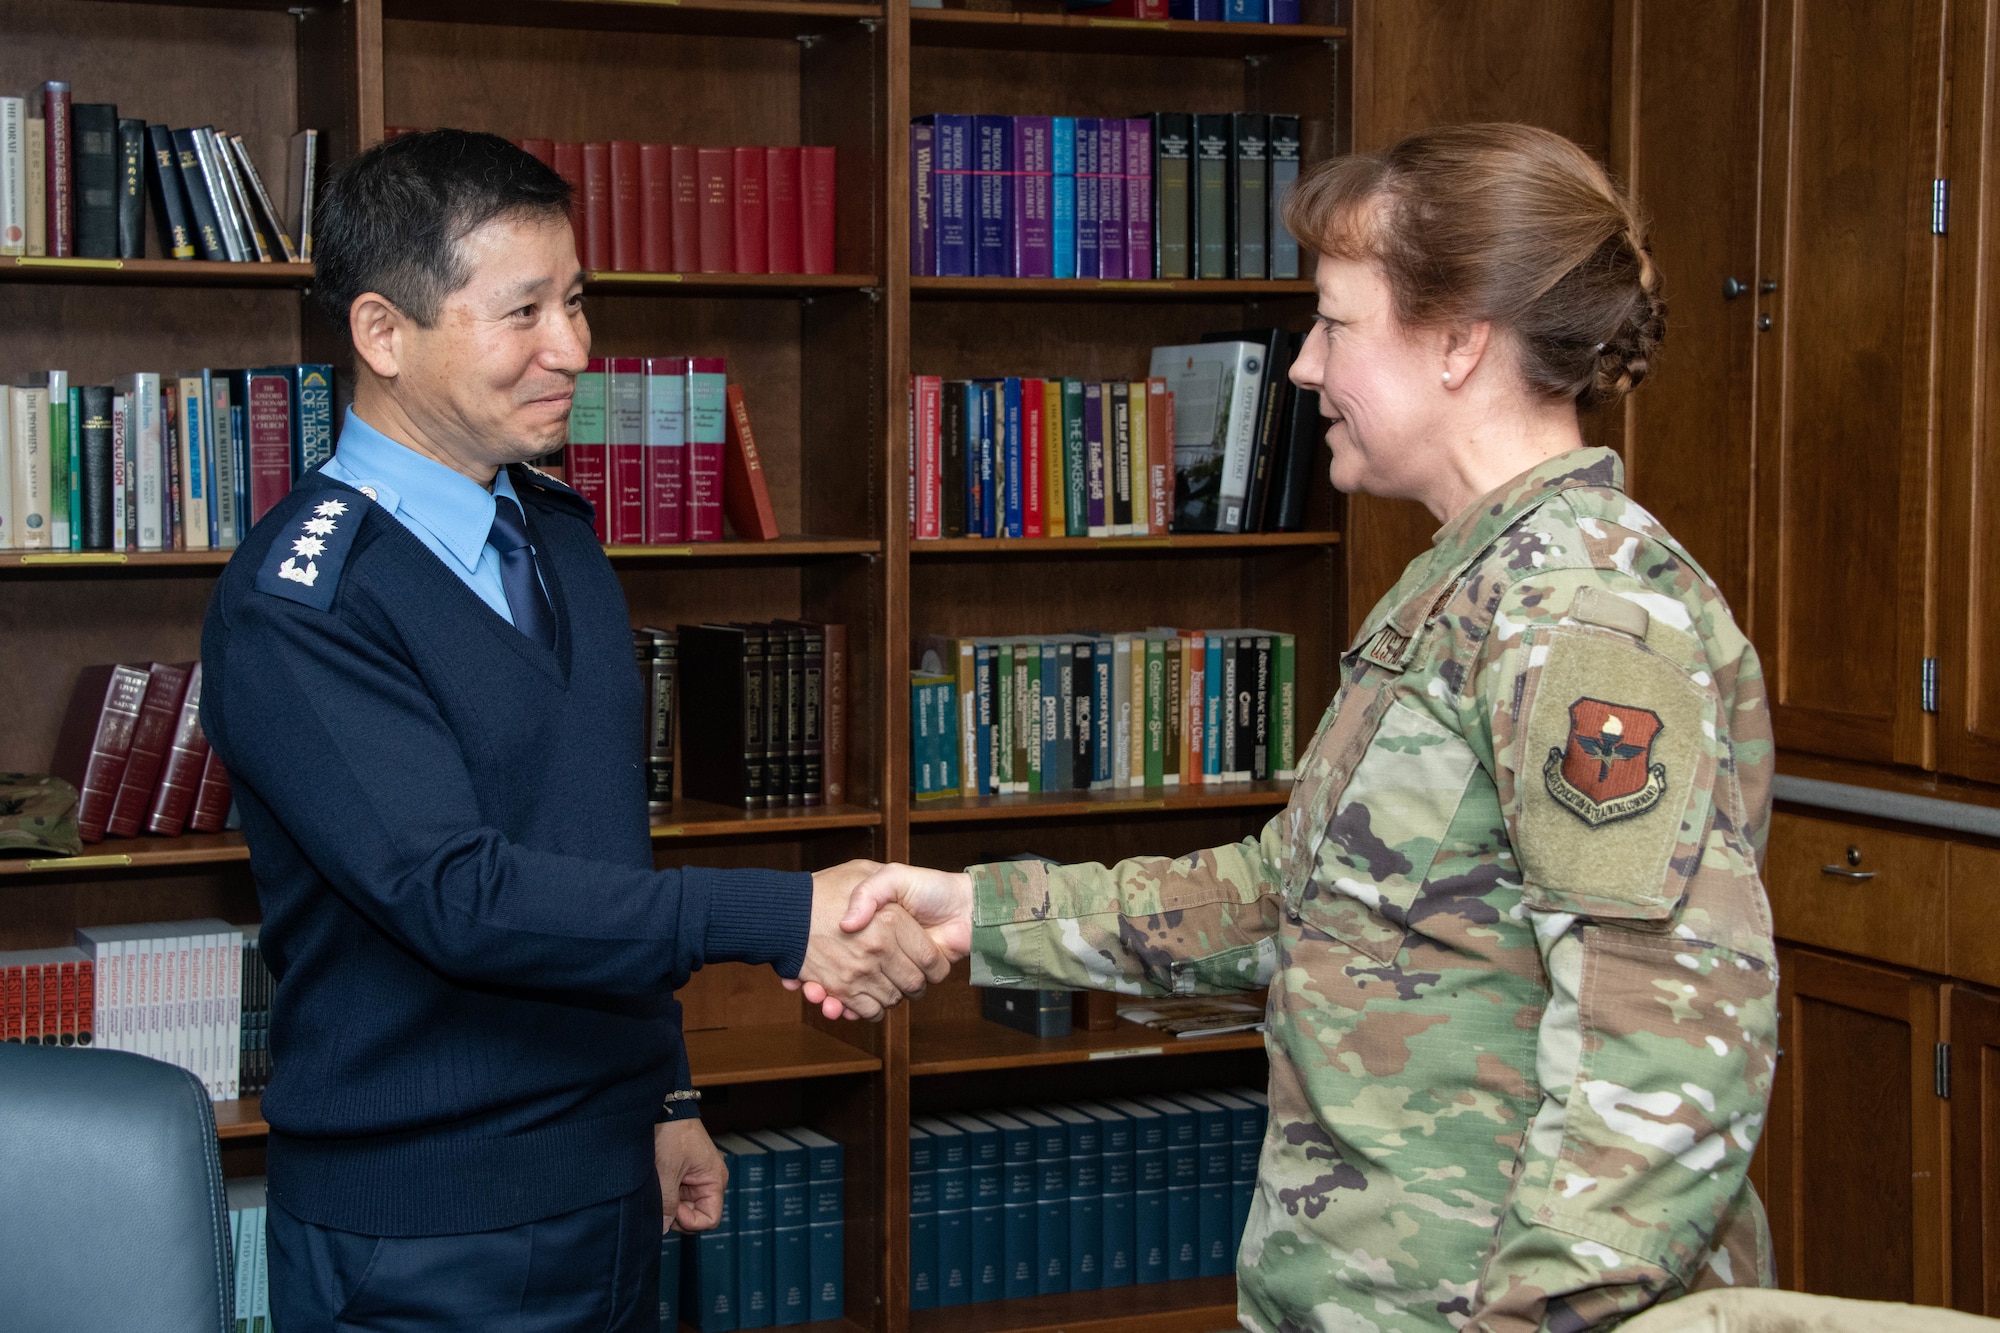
[[564, 356, 778, 546]]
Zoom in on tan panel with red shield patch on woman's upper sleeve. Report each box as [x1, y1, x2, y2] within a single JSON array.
[[1516, 628, 1716, 921]]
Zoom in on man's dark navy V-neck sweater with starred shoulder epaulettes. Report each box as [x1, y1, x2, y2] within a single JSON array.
[[202, 468, 812, 1235]]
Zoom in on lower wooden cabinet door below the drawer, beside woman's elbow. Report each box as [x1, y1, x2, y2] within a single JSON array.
[[1760, 947, 1948, 1305]]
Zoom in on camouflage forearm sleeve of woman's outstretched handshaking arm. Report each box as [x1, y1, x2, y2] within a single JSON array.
[[968, 819, 1282, 995]]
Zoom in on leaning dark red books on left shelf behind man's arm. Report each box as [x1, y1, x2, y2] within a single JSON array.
[[48, 662, 230, 843]]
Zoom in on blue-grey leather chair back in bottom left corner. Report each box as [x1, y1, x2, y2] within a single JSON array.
[[0, 1045, 234, 1333]]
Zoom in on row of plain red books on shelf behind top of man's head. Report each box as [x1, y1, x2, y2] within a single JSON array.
[[388, 126, 834, 274]]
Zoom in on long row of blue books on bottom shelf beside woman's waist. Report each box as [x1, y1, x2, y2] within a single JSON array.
[[910, 1087, 1268, 1309]]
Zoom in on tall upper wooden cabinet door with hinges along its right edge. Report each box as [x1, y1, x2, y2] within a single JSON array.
[[1752, 0, 1944, 763]]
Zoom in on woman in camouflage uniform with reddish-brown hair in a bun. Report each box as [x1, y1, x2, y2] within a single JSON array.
[[828, 124, 1776, 1333]]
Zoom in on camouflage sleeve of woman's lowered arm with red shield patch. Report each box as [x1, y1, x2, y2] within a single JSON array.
[[1466, 568, 1776, 1333]]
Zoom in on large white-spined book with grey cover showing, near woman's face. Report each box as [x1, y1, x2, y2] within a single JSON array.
[[1148, 342, 1264, 532]]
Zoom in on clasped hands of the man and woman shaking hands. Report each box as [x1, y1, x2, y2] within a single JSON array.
[[784, 861, 972, 1019]]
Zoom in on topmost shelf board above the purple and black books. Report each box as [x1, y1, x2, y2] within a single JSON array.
[[910, 8, 1348, 56]]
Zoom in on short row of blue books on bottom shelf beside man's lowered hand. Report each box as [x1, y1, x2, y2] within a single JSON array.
[[680, 1127, 846, 1333]]
